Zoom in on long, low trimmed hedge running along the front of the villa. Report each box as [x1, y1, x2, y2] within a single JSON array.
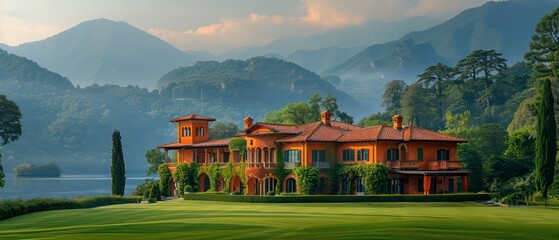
[[184, 193, 489, 203]]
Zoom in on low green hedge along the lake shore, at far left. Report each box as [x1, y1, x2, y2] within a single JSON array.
[[0, 196, 142, 220]]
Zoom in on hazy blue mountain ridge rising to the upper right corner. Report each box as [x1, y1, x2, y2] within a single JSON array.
[[324, 0, 559, 111]]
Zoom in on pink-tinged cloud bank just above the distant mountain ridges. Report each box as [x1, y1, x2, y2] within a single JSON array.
[[148, 0, 487, 54]]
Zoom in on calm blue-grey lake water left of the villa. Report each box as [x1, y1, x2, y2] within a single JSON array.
[[0, 174, 152, 200]]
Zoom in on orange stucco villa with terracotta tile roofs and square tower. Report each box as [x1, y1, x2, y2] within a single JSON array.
[[158, 111, 469, 195]]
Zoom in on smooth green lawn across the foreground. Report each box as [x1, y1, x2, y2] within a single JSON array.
[[0, 199, 559, 240]]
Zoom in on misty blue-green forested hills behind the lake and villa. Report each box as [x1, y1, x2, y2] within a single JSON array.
[[0, 50, 355, 173]]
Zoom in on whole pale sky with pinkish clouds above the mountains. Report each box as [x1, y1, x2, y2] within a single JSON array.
[[0, 0, 487, 54]]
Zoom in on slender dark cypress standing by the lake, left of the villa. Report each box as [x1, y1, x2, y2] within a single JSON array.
[[111, 130, 126, 196]]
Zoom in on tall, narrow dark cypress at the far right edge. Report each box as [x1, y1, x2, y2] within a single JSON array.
[[536, 80, 557, 205]]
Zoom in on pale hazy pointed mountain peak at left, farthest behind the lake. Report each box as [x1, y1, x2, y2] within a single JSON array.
[[3, 19, 198, 89]]
